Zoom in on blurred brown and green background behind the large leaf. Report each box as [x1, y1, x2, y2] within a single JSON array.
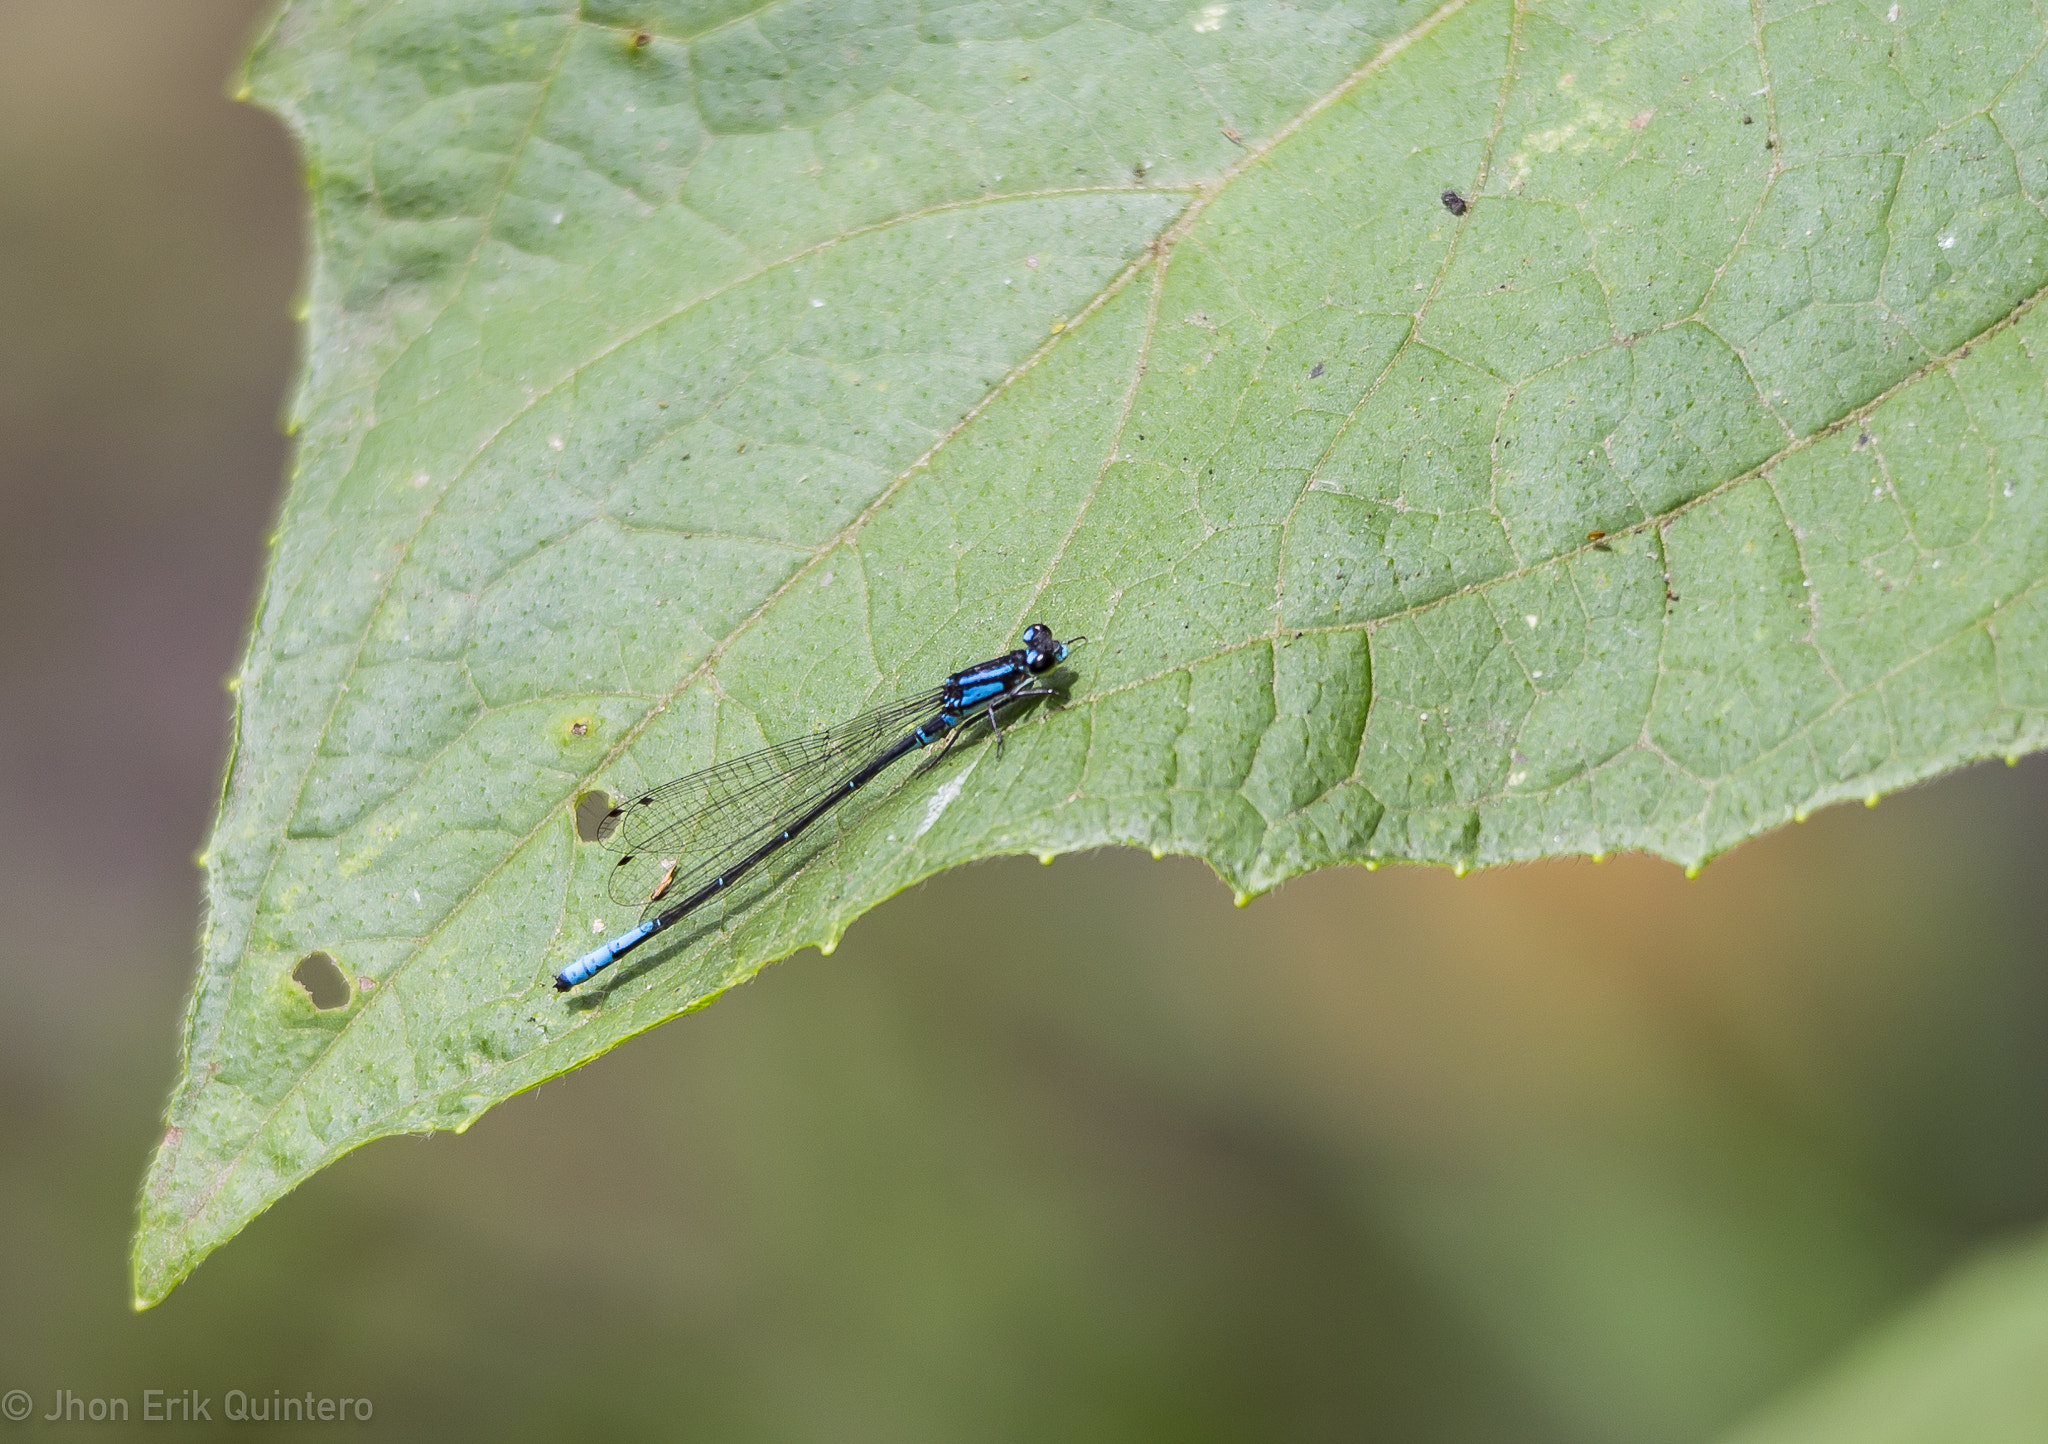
[[0, 0, 2048, 1444]]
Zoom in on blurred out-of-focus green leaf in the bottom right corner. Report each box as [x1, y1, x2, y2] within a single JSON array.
[[1724, 1212, 2048, 1444]]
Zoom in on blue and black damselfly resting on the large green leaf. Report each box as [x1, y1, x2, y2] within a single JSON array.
[[555, 623, 1083, 993]]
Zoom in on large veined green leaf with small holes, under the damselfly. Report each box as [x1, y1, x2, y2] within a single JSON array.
[[135, 0, 2048, 1303]]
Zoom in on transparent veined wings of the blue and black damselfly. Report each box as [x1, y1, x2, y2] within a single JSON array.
[[598, 688, 940, 911]]
